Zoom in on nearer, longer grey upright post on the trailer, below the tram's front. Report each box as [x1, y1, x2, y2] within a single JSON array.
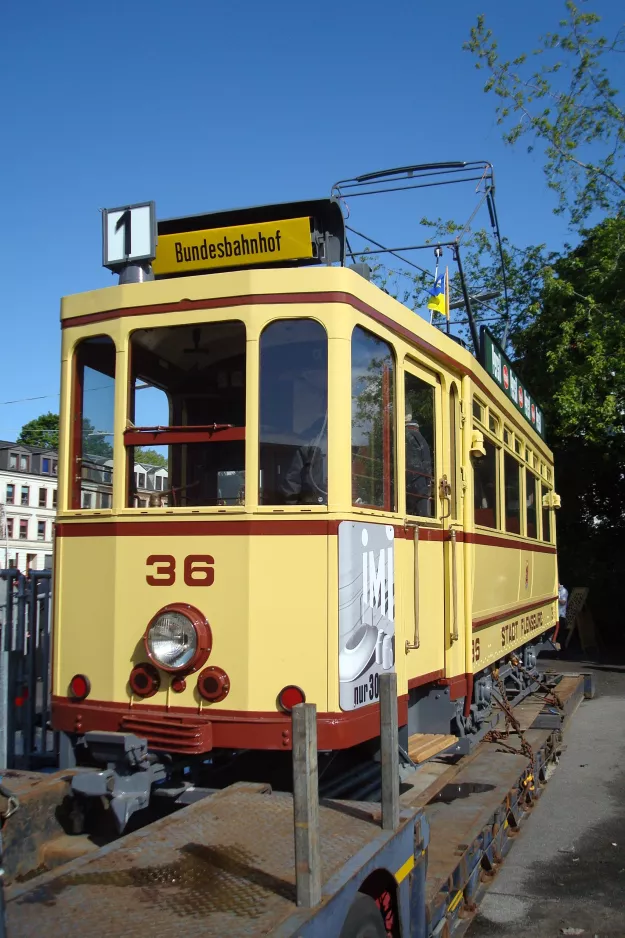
[[293, 704, 321, 909]]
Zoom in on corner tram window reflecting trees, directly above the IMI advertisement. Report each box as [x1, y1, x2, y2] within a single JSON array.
[[352, 326, 396, 511]]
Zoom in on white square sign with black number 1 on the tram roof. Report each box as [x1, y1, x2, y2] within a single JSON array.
[[102, 202, 156, 270]]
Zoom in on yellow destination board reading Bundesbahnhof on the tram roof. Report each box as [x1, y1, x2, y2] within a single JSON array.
[[152, 218, 313, 276]]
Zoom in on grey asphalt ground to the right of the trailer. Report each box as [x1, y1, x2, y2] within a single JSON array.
[[467, 655, 625, 938]]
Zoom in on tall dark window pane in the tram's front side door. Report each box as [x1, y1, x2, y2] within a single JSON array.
[[404, 372, 436, 518]]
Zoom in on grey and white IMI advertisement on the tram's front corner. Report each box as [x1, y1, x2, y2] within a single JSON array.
[[339, 521, 395, 710]]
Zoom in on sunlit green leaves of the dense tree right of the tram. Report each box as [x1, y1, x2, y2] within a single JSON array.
[[514, 218, 625, 442]]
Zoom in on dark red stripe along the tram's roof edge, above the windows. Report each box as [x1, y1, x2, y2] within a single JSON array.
[[61, 290, 551, 462]]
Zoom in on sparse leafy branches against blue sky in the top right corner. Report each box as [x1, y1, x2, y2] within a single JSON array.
[[464, 0, 625, 226]]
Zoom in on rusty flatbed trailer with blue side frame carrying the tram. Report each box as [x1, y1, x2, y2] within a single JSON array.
[[3, 675, 592, 938]]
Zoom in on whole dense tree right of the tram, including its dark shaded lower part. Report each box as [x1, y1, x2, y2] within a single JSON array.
[[514, 217, 625, 643]]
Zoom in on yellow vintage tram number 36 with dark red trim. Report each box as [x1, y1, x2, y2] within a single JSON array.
[[53, 183, 558, 812]]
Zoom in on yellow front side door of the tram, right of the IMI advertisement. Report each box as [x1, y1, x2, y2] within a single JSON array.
[[403, 362, 449, 688]]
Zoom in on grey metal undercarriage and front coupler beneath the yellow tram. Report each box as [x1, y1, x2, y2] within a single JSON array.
[[67, 636, 557, 833]]
